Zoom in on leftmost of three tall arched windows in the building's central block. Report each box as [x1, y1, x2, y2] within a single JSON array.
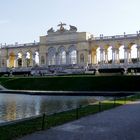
[[48, 47, 56, 65]]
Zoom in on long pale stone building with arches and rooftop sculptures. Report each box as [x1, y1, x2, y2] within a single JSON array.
[[0, 23, 140, 71]]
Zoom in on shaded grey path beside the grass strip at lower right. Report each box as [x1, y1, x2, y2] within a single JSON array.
[[19, 101, 140, 140]]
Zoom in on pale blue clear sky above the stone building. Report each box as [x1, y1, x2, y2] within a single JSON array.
[[0, 0, 140, 44]]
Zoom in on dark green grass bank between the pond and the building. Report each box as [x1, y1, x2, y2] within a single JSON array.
[[0, 75, 140, 91]]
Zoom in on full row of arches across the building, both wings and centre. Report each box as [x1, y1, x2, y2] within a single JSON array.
[[6, 44, 140, 67]]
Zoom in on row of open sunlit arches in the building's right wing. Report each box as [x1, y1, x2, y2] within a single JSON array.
[[92, 44, 139, 64]]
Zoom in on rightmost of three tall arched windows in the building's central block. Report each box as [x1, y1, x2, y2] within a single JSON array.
[[69, 46, 77, 64]]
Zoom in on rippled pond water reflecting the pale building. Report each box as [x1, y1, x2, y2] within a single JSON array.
[[0, 94, 97, 122]]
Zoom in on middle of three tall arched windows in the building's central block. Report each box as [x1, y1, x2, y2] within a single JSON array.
[[58, 47, 66, 65]]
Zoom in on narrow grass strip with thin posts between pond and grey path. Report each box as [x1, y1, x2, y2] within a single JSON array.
[[0, 98, 131, 140]]
